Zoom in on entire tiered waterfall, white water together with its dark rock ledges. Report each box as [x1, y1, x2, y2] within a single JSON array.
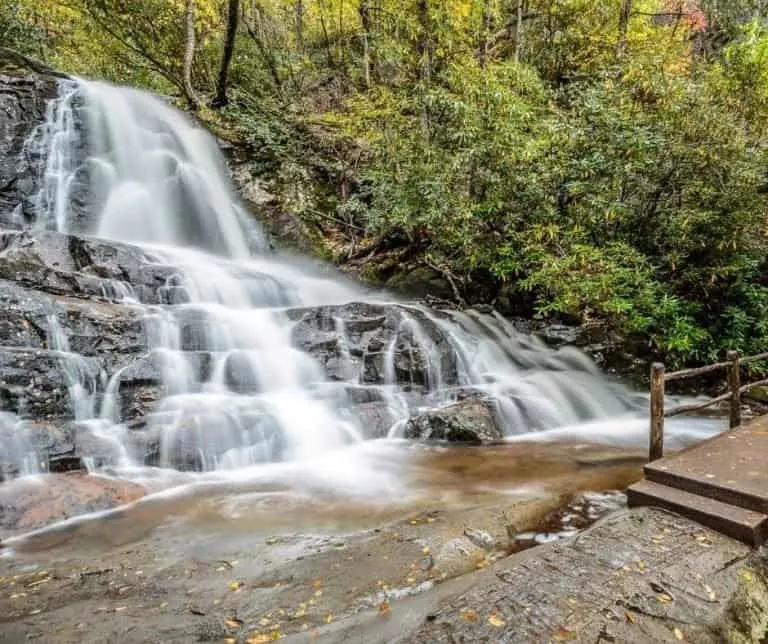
[[0, 56, 648, 494]]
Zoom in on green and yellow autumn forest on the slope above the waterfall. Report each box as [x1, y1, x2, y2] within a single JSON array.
[[0, 0, 768, 362]]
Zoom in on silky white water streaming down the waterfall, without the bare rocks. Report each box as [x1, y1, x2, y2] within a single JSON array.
[[0, 81, 714, 491]]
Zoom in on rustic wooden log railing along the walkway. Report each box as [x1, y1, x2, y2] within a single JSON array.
[[648, 351, 768, 461]]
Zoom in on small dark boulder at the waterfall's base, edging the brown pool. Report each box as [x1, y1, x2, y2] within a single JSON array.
[[405, 398, 504, 444]]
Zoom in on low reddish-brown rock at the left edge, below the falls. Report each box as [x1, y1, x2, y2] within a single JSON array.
[[0, 472, 146, 530]]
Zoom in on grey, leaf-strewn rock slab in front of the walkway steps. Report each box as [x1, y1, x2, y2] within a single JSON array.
[[296, 508, 768, 644]]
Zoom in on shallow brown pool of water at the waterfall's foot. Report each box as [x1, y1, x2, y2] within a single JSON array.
[[5, 442, 644, 553]]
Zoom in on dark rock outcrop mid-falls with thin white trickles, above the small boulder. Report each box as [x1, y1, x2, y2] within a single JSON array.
[[288, 303, 458, 391]]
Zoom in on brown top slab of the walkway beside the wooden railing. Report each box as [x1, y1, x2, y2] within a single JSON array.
[[645, 416, 768, 513]]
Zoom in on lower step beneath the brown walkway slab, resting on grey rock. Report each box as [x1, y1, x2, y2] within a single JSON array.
[[627, 480, 768, 546]]
